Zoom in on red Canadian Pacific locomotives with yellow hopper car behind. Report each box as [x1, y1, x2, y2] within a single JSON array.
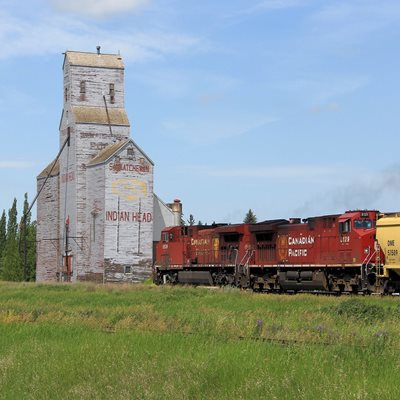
[[153, 210, 400, 294]]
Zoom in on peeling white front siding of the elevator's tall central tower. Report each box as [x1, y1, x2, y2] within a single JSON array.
[[60, 57, 129, 280]]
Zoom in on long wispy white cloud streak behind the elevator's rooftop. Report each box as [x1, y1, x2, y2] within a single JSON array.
[[0, 7, 199, 61]]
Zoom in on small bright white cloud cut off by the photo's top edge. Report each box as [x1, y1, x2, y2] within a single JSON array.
[[50, 0, 150, 18]]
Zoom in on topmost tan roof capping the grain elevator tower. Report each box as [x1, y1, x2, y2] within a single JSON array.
[[64, 50, 124, 69]]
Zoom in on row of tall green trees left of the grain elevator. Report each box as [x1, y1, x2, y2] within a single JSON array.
[[0, 193, 36, 281]]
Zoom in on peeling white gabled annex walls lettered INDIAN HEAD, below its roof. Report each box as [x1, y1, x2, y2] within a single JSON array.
[[87, 142, 153, 281]]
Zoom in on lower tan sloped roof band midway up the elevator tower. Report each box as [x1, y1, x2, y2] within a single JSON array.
[[71, 106, 130, 126]]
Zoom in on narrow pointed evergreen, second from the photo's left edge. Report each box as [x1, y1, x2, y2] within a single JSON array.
[[1, 199, 23, 281]]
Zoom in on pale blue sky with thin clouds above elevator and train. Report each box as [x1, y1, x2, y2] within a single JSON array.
[[0, 0, 400, 223]]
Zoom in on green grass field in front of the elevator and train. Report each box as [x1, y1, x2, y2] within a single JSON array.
[[0, 283, 400, 400]]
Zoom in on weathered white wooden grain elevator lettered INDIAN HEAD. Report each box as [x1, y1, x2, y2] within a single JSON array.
[[36, 48, 182, 282]]
